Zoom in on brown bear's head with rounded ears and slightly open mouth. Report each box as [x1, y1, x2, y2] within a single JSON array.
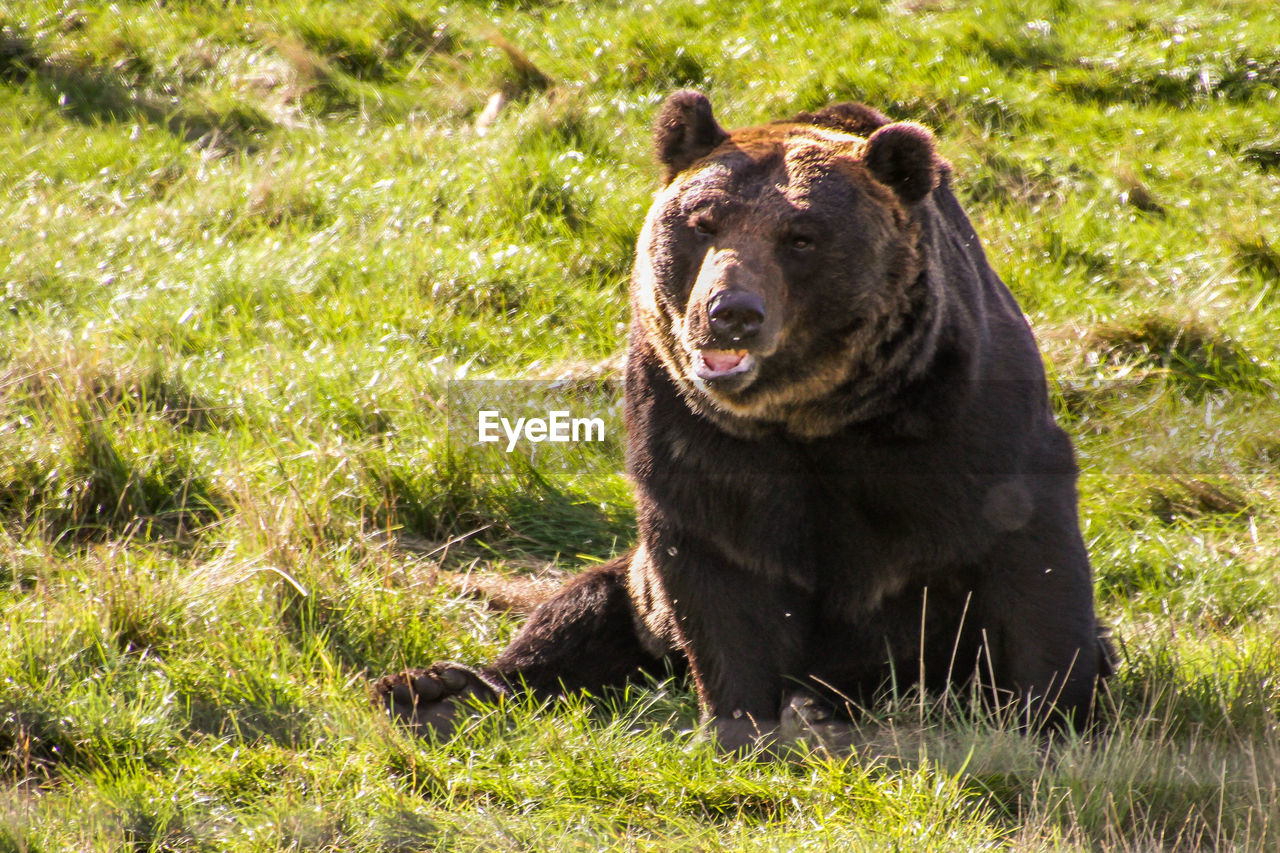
[[632, 91, 947, 438]]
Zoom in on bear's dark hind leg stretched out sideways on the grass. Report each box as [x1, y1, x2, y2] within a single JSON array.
[[374, 555, 663, 739]]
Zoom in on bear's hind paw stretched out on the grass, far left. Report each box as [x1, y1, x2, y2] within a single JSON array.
[[374, 662, 499, 740]]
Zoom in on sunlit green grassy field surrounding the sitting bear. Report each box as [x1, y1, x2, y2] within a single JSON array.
[[0, 0, 1280, 852]]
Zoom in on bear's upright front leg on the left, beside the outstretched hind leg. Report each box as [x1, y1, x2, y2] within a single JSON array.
[[646, 525, 813, 751]]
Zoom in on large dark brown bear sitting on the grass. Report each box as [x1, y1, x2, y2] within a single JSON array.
[[375, 91, 1110, 747]]
